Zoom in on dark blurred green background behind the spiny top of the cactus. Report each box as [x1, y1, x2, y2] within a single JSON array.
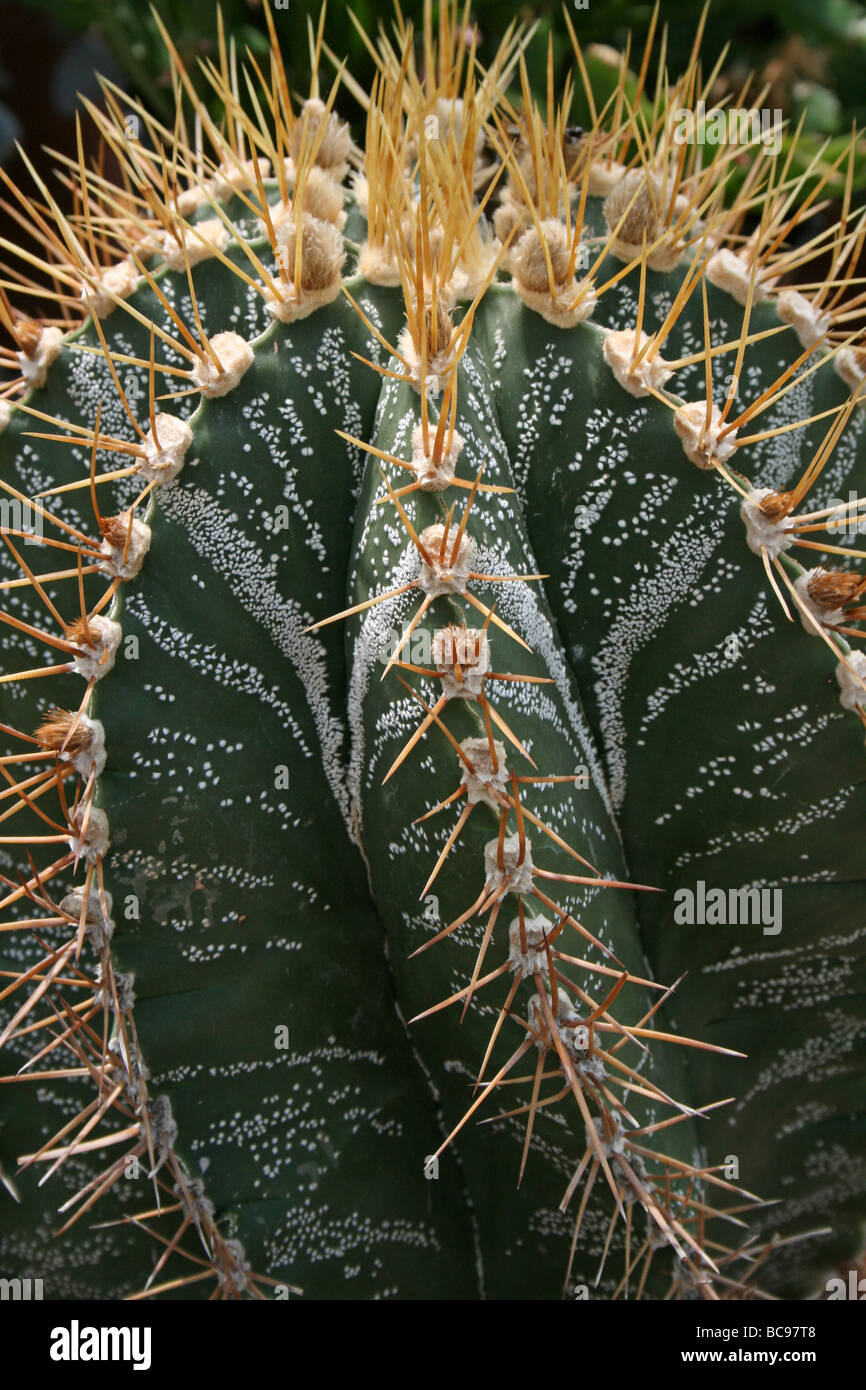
[[0, 0, 866, 157]]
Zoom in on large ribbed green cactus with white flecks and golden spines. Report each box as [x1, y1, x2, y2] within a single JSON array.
[[0, 7, 866, 1300]]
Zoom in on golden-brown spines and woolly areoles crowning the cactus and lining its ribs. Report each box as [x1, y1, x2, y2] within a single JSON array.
[[0, 6, 866, 1298]]
